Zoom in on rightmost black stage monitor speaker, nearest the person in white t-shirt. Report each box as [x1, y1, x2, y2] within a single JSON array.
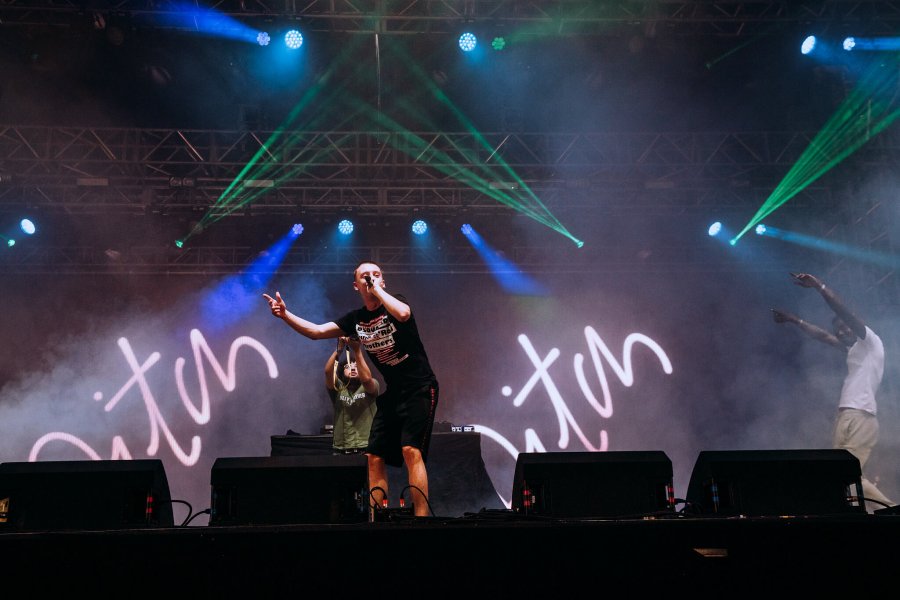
[[686, 449, 866, 516]]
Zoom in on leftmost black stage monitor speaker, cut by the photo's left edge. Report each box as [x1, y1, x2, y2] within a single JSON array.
[[0, 459, 173, 531]]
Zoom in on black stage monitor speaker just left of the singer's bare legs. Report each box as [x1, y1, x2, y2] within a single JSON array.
[[209, 454, 369, 525]]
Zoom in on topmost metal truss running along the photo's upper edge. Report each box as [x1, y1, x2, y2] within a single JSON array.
[[0, 0, 900, 37]]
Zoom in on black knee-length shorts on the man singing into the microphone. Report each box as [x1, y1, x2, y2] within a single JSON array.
[[367, 381, 438, 467]]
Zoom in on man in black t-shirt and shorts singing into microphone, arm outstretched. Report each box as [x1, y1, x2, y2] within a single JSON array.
[[263, 262, 438, 517]]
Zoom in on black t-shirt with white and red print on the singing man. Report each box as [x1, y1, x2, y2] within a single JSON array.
[[335, 294, 435, 388]]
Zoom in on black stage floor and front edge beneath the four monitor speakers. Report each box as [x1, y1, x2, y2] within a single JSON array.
[[0, 510, 900, 598]]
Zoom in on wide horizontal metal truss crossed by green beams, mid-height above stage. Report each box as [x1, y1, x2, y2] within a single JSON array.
[[0, 126, 900, 216]]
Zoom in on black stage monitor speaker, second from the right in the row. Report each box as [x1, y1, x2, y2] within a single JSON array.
[[511, 451, 675, 518]]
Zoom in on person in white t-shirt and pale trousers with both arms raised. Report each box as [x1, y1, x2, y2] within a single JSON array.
[[772, 273, 894, 510]]
